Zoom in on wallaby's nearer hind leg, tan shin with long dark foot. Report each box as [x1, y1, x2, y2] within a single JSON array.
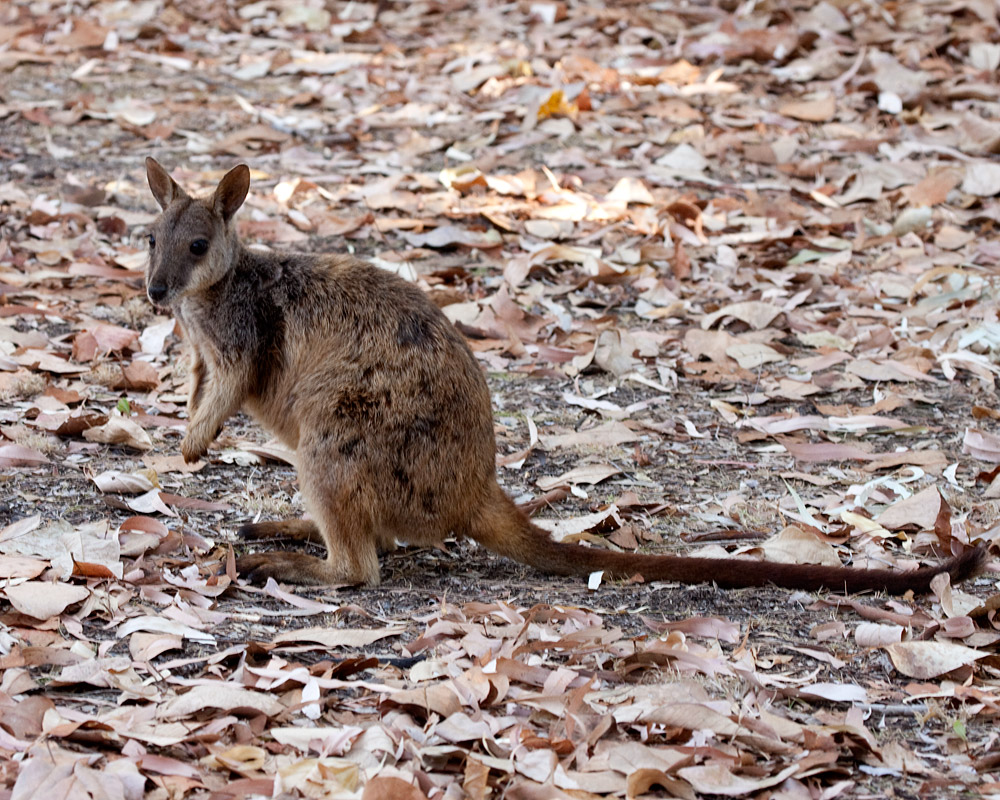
[[236, 456, 379, 586]]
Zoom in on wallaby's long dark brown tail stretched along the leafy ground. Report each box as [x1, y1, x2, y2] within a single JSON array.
[[470, 486, 987, 595]]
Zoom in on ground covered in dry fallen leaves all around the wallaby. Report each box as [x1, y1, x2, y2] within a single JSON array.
[[0, 0, 1000, 798]]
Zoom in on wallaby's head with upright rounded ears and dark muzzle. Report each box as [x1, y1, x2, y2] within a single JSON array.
[[146, 158, 250, 306]]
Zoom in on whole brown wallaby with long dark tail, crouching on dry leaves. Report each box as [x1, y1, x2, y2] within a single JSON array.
[[146, 158, 985, 594]]
